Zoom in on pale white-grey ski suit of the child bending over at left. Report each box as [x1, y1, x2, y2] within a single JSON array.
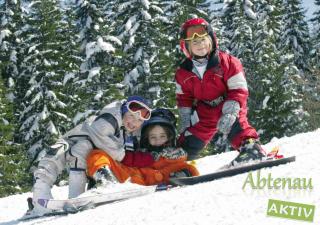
[[34, 101, 137, 186]]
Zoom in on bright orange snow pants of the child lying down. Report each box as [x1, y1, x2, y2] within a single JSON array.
[[87, 149, 199, 185]]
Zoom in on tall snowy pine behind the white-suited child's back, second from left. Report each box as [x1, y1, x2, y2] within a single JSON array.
[[16, 0, 75, 160]]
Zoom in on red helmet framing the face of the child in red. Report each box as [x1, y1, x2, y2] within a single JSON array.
[[180, 18, 217, 59]]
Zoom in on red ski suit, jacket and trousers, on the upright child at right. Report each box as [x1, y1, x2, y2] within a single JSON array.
[[175, 50, 258, 148]]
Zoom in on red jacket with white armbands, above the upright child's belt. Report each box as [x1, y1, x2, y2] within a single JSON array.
[[175, 51, 248, 108]]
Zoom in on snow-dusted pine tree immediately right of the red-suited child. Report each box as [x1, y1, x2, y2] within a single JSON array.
[[249, 0, 307, 141]]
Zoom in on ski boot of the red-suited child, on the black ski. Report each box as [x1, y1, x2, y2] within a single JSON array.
[[231, 138, 266, 166]]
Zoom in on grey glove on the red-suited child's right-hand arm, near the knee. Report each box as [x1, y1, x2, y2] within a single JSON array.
[[217, 100, 240, 135]]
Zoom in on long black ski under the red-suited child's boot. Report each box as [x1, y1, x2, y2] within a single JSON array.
[[170, 156, 296, 186]]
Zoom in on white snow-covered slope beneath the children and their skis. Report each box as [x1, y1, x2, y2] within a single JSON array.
[[0, 129, 320, 225]]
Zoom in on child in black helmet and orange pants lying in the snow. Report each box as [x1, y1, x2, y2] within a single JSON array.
[[87, 109, 199, 185]]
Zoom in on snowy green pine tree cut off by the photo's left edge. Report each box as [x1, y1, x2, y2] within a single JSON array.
[[0, 0, 31, 197]]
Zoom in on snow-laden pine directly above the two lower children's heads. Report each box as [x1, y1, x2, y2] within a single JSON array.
[[105, 0, 168, 103]]
